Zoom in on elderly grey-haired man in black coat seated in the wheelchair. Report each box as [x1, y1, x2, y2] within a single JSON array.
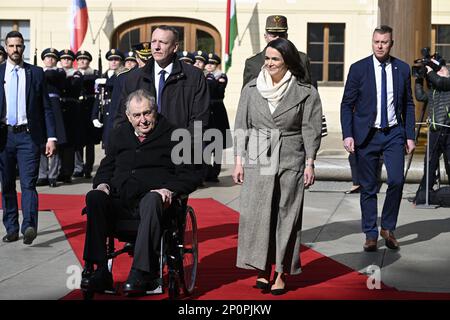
[[81, 90, 199, 294]]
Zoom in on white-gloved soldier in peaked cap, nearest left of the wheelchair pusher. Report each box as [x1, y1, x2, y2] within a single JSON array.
[[91, 49, 124, 152]]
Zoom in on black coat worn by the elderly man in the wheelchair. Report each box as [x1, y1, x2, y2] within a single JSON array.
[[94, 116, 199, 208]]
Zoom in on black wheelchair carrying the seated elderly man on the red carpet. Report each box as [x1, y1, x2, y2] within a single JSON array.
[[81, 195, 198, 300]]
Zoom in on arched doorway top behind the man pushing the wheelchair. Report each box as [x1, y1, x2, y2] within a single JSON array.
[[111, 17, 222, 56]]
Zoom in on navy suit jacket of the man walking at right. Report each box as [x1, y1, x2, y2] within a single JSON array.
[[341, 55, 415, 146]]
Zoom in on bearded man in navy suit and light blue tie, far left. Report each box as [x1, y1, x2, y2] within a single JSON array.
[[0, 31, 56, 244]]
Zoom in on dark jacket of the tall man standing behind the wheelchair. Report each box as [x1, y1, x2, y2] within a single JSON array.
[[114, 56, 209, 132]]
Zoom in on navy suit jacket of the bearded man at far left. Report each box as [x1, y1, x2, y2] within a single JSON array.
[[0, 62, 56, 147]]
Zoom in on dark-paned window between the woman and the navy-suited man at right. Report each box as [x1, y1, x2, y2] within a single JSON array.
[[308, 23, 345, 83]]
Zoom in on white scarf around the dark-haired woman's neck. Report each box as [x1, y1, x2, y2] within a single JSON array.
[[256, 68, 295, 113]]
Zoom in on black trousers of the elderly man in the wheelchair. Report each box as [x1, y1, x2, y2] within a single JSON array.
[[83, 190, 164, 273]]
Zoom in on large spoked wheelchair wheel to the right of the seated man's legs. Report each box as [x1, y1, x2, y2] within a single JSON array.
[[179, 206, 198, 295]]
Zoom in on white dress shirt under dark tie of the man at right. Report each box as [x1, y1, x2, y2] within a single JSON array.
[[373, 56, 397, 128]]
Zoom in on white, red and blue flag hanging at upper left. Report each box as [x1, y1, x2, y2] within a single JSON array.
[[70, 0, 89, 53]]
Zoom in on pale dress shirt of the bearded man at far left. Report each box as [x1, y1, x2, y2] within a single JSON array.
[[4, 60, 28, 125]]
